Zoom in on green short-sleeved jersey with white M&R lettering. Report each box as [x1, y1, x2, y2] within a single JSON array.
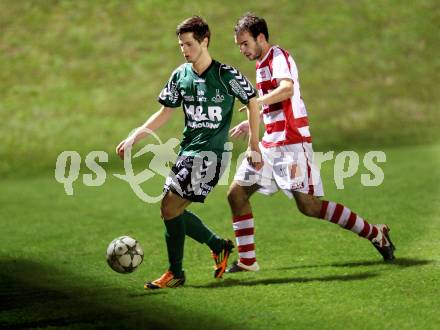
[[158, 60, 256, 156]]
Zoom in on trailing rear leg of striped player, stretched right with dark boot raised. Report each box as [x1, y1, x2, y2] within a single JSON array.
[[293, 191, 395, 261]]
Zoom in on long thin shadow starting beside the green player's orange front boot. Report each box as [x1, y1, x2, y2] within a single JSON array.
[[189, 272, 377, 289]]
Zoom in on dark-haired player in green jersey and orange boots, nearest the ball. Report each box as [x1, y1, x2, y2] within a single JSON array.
[[116, 16, 262, 289]]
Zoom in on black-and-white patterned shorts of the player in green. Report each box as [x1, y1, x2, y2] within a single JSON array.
[[163, 156, 222, 203]]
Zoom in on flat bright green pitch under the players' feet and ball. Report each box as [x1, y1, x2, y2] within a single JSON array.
[[0, 145, 440, 329]]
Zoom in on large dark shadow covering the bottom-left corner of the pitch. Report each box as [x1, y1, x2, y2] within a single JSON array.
[[0, 259, 237, 329]]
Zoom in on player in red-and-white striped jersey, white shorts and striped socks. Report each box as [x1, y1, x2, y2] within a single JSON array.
[[227, 13, 394, 273]]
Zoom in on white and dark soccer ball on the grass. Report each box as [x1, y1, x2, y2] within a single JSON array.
[[107, 236, 144, 274]]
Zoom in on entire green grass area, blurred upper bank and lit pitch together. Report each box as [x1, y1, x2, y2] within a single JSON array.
[[0, 0, 440, 330]]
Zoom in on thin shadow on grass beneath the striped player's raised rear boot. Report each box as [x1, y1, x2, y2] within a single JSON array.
[[272, 258, 434, 270]]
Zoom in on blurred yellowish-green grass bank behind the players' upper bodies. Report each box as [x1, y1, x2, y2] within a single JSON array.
[[0, 0, 440, 175]]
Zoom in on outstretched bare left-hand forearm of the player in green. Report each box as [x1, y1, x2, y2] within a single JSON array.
[[116, 106, 173, 159]]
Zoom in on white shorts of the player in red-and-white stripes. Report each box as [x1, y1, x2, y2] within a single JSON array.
[[234, 143, 324, 198]]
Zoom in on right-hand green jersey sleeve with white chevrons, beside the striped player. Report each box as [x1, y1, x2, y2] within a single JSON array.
[[221, 64, 257, 104]]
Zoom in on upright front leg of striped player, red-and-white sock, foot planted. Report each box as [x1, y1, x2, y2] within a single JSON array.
[[226, 181, 260, 273]]
